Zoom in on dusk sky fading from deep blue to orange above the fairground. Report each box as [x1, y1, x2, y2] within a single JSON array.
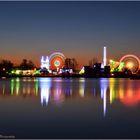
[[0, 1, 140, 65]]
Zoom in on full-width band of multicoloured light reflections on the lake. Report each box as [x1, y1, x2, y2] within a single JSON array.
[[0, 78, 140, 116]]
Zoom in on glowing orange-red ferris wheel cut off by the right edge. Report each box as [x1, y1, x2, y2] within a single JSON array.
[[120, 54, 140, 73]]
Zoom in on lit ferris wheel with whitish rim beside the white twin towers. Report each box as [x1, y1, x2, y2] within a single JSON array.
[[49, 52, 65, 70]]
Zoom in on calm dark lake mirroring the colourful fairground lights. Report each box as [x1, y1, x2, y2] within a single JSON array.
[[0, 78, 140, 139]]
